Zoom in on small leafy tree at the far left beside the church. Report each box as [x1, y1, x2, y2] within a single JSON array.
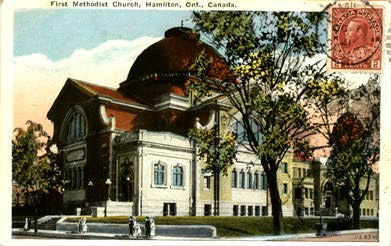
[[12, 121, 64, 232]]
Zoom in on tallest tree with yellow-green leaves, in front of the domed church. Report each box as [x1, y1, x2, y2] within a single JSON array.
[[189, 12, 343, 234]]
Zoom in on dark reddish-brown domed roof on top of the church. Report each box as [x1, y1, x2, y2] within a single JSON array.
[[127, 27, 227, 81]]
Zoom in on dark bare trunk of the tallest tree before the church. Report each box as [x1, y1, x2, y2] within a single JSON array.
[[267, 171, 282, 235]]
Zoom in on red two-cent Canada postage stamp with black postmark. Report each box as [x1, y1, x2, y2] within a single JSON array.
[[329, 7, 383, 72]]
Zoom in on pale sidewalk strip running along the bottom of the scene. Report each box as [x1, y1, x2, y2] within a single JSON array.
[[12, 229, 378, 241]]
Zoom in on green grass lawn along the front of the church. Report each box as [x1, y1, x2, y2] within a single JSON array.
[[67, 216, 378, 237]]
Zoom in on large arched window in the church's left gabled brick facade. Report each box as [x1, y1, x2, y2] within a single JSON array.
[[63, 106, 87, 142]]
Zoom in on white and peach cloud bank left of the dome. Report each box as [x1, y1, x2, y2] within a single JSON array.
[[14, 37, 160, 135]]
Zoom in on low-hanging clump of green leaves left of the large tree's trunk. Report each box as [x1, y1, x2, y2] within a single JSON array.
[[189, 128, 237, 175]]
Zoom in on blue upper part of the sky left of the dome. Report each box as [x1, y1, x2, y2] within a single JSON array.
[[14, 9, 192, 60]]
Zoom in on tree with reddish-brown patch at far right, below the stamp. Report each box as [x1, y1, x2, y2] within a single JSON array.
[[327, 76, 380, 229]]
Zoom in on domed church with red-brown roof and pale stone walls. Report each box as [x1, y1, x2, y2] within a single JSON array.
[[47, 27, 377, 216]]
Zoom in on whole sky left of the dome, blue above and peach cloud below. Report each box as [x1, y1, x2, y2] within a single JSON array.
[[13, 9, 192, 135]]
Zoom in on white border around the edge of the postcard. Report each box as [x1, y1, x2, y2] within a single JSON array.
[[0, 0, 391, 246]]
